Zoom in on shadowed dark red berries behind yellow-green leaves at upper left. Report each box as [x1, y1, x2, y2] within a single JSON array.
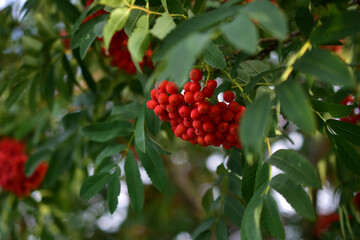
[[83, 0, 154, 74]]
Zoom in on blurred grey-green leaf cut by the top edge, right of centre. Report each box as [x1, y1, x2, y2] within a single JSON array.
[[242, 1, 288, 40]]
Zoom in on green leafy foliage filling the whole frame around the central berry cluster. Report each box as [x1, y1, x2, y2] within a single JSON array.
[[0, 0, 360, 240]]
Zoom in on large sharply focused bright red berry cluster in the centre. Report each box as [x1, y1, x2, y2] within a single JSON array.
[[146, 69, 245, 149]]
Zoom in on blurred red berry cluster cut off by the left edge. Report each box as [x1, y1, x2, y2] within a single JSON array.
[[0, 138, 48, 197]]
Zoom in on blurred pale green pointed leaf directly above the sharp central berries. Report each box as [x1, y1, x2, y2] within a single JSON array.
[[220, 14, 259, 54]]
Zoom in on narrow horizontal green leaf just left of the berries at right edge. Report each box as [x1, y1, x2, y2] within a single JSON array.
[[312, 100, 354, 118]]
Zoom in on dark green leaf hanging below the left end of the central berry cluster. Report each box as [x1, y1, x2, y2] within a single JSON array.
[[135, 144, 167, 192]]
